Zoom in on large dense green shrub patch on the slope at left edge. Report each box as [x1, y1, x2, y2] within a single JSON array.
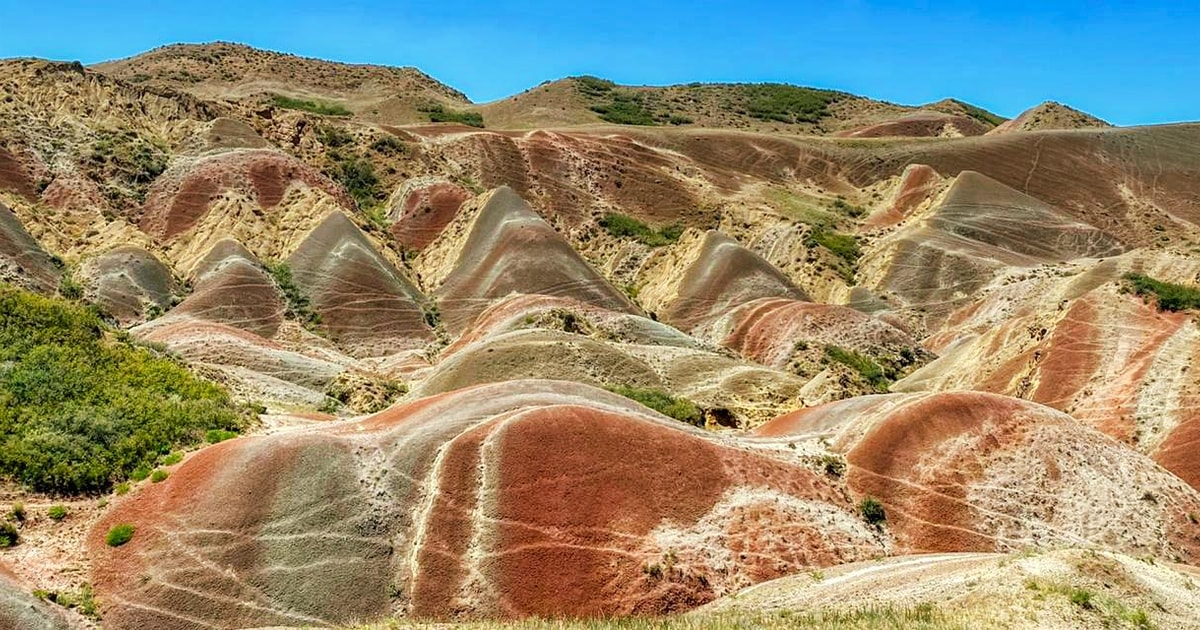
[[0, 287, 247, 493]]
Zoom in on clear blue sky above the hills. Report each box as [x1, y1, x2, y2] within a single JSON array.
[[0, 0, 1200, 125]]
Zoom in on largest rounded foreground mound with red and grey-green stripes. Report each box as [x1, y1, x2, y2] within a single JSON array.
[[89, 382, 881, 629]]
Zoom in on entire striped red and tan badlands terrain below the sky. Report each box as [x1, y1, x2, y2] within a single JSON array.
[[0, 43, 1200, 630]]
